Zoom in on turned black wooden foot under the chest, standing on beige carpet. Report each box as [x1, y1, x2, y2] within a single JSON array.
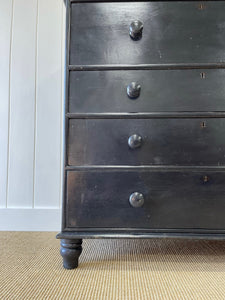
[[60, 239, 82, 269]]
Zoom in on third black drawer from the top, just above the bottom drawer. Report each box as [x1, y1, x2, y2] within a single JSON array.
[[67, 118, 225, 166]]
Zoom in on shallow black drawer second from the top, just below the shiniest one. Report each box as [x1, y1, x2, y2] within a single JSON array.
[[69, 69, 225, 113]]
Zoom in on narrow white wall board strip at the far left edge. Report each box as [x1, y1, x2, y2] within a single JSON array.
[[0, 0, 12, 207]]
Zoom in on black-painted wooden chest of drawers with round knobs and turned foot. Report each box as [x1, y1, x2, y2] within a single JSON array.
[[57, 0, 225, 269]]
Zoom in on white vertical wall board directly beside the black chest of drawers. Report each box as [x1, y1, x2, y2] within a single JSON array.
[[34, 0, 63, 208]]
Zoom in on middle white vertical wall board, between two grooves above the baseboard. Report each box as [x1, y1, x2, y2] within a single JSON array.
[[7, 0, 37, 208]]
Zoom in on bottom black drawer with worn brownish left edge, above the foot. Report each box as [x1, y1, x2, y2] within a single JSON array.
[[65, 170, 225, 229]]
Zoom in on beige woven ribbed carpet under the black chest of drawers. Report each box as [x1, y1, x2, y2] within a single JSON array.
[[0, 232, 225, 300]]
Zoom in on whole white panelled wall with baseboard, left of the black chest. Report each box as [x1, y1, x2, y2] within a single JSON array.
[[0, 0, 65, 231]]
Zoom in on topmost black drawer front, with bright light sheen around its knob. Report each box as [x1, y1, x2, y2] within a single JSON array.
[[69, 1, 225, 65]]
